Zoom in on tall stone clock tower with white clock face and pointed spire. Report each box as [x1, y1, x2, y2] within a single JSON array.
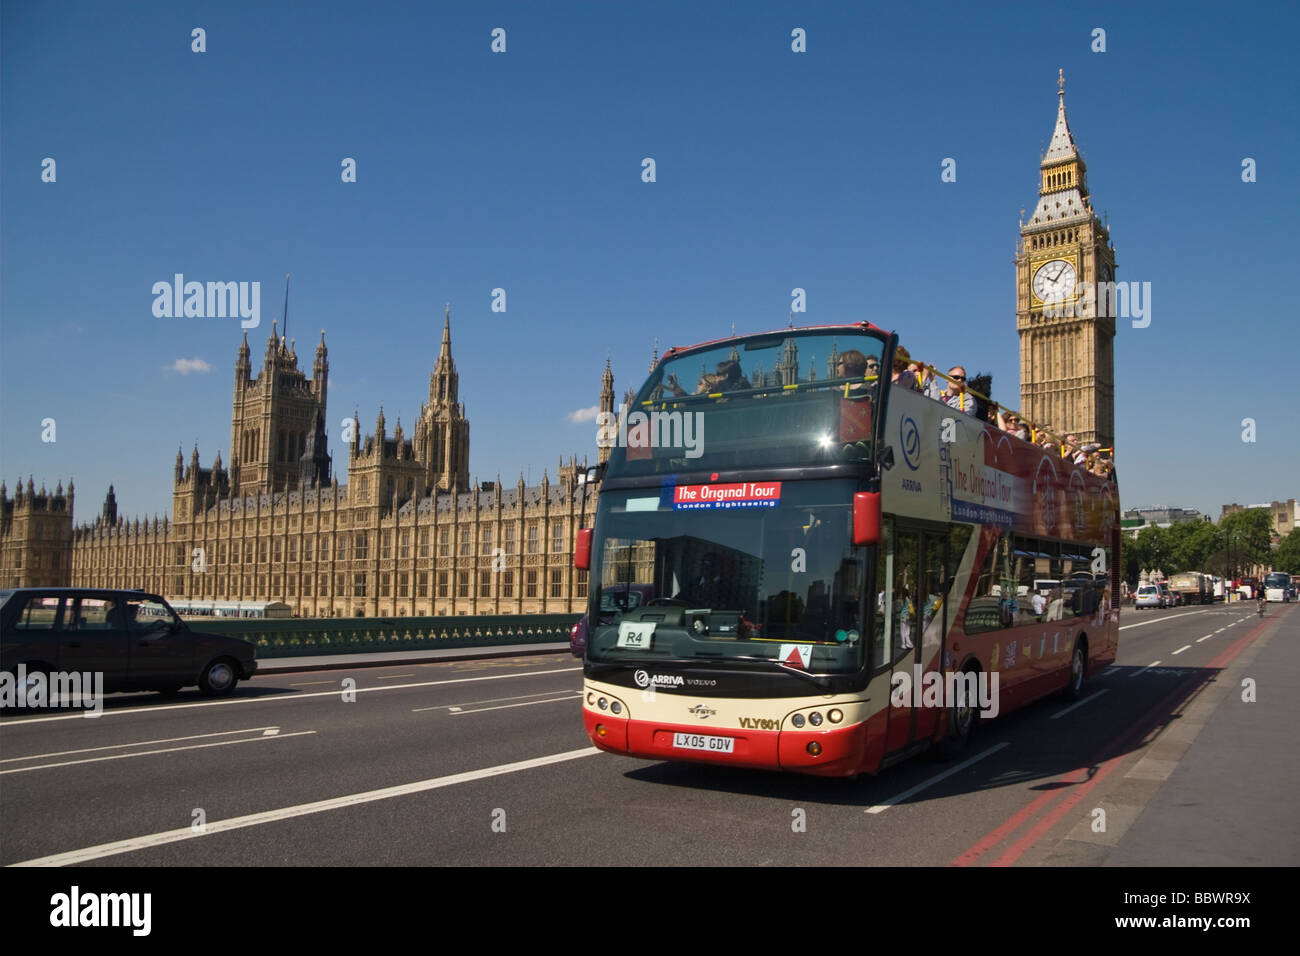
[[1015, 72, 1115, 447]]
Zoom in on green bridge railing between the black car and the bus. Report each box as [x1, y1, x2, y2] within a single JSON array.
[[186, 614, 577, 657]]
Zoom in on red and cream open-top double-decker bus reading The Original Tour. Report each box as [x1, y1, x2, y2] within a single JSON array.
[[575, 323, 1119, 777]]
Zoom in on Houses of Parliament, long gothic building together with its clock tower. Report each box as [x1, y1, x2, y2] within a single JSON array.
[[0, 77, 1115, 617]]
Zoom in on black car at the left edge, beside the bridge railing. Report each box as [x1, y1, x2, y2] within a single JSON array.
[[0, 588, 257, 697]]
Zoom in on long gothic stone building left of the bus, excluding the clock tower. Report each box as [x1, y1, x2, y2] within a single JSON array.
[[0, 315, 598, 617]]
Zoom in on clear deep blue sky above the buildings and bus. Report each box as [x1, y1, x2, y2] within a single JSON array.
[[0, 0, 1300, 520]]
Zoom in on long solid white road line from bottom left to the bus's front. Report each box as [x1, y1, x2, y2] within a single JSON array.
[[9, 747, 599, 866]]
